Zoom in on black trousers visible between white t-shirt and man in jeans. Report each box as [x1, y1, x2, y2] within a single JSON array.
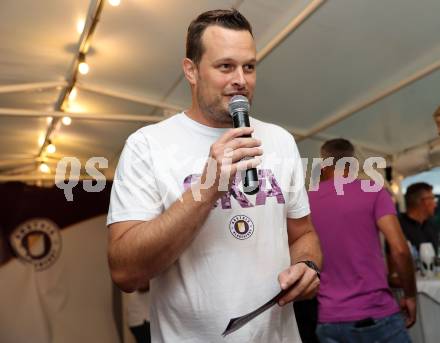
[[293, 298, 319, 343]]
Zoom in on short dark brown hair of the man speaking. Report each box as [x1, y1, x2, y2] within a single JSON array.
[[186, 8, 252, 65]]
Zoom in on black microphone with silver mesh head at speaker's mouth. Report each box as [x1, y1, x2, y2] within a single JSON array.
[[229, 95, 259, 195]]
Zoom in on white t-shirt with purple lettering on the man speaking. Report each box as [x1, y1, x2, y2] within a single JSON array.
[[107, 113, 310, 343]]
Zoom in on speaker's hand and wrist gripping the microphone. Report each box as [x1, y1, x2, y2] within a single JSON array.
[[197, 127, 263, 200]]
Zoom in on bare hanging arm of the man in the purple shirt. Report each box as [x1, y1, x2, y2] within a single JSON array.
[[377, 214, 417, 327]]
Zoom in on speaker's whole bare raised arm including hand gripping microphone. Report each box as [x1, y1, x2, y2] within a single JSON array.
[[108, 128, 262, 291]]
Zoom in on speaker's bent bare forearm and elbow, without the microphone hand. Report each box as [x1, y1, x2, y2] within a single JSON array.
[[108, 190, 215, 292]]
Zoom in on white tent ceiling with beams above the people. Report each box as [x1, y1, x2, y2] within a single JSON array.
[[0, 0, 440, 180]]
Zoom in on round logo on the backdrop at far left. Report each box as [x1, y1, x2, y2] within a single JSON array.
[[10, 218, 61, 271]]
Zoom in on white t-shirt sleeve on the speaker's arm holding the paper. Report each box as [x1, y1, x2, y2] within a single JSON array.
[[287, 133, 310, 219]]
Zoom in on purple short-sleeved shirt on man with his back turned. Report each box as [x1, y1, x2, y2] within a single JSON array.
[[309, 179, 399, 323]]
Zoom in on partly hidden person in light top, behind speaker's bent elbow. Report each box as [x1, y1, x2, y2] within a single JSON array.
[[126, 288, 151, 343]]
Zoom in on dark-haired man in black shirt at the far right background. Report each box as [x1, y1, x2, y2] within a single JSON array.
[[399, 182, 439, 252]]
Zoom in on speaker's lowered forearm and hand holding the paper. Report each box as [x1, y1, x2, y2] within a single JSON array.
[[278, 215, 322, 305]]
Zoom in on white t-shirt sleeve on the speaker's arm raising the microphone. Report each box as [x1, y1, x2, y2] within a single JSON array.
[[107, 132, 163, 225]]
